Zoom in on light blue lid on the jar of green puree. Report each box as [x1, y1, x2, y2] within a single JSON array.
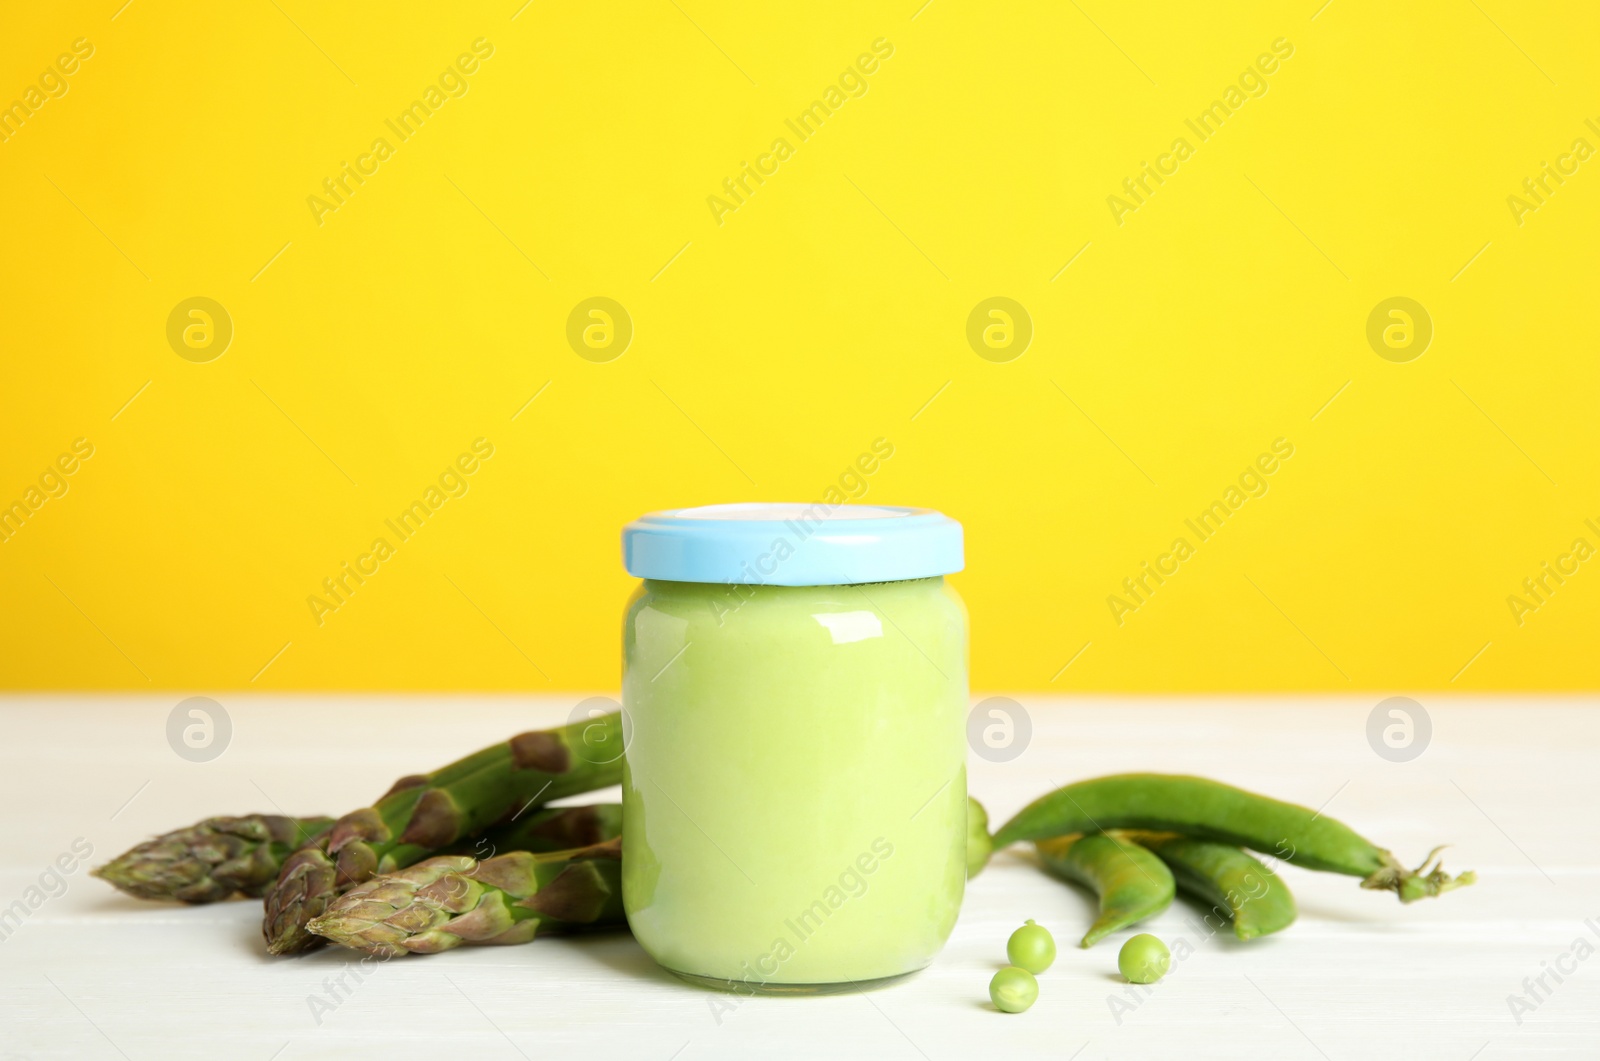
[[622, 501, 965, 586]]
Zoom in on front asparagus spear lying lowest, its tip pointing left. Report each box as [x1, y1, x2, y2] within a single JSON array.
[[307, 839, 626, 959]]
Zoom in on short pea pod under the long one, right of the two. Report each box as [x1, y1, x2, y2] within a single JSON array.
[[1128, 832, 1296, 939]]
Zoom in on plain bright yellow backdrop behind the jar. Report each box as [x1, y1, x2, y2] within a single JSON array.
[[0, 0, 1600, 691]]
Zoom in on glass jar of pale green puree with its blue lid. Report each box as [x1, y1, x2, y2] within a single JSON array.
[[622, 504, 966, 992]]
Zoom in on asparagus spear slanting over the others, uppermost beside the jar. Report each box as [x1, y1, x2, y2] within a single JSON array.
[[261, 723, 622, 954]]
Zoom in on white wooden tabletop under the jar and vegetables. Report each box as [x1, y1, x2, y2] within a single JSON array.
[[0, 696, 1600, 1061]]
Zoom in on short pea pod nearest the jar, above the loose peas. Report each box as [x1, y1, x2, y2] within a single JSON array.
[[1034, 834, 1174, 947]]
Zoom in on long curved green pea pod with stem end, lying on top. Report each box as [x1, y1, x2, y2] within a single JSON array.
[[994, 773, 1477, 903]]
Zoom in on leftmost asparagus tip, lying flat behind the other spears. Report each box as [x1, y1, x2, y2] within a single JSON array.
[[93, 815, 333, 903]]
